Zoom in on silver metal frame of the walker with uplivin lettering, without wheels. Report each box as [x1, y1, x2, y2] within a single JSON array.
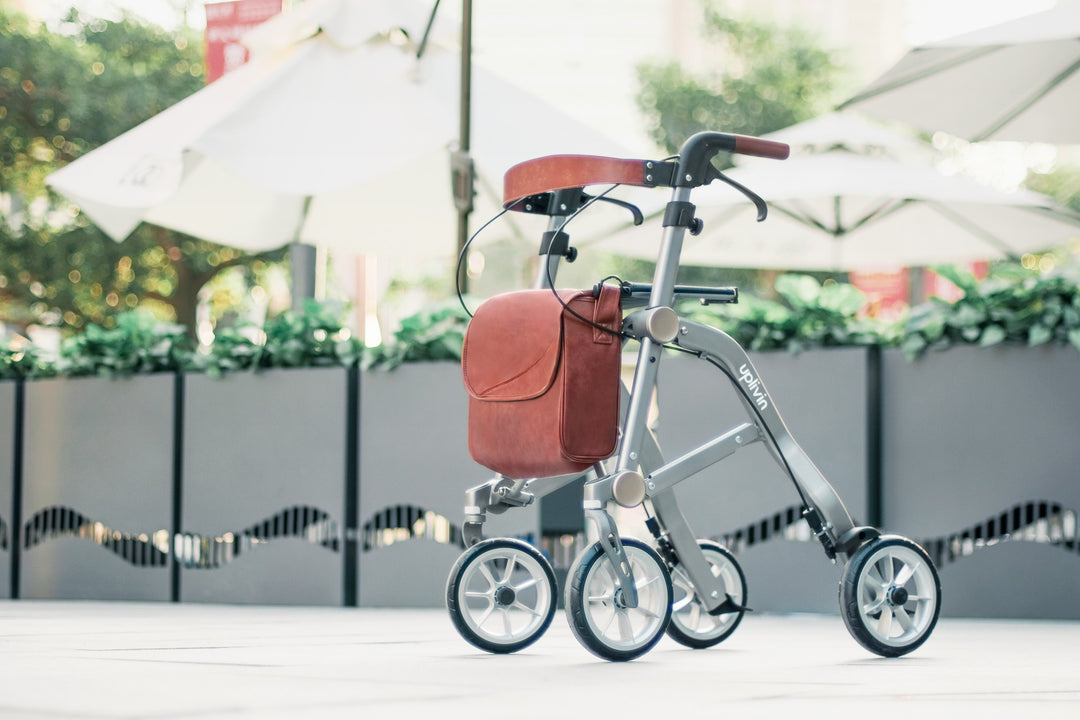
[[463, 179, 879, 613]]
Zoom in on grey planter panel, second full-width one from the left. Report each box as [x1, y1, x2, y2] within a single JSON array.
[[179, 368, 348, 606]]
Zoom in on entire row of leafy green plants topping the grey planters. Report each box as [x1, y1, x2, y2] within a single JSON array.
[[8, 263, 1080, 380]]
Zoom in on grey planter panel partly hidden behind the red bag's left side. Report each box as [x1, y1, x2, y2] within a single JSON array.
[[357, 363, 539, 608]]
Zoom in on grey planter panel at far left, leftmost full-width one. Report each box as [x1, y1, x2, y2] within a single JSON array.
[[19, 375, 175, 600]]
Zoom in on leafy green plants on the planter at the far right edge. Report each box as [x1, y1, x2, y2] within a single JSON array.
[[901, 263, 1080, 358]]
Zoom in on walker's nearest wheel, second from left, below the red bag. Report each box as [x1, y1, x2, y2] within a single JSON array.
[[566, 540, 672, 661]]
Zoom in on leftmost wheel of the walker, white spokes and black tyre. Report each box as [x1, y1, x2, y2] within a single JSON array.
[[446, 538, 555, 653]]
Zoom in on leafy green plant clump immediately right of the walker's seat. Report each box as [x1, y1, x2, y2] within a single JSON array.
[[683, 274, 899, 352]]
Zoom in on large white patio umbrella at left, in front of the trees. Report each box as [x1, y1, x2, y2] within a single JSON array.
[[49, 0, 622, 260]]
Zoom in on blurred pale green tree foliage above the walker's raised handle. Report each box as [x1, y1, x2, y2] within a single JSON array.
[[637, 0, 842, 152]]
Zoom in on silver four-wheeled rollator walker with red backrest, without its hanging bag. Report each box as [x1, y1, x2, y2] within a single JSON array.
[[446, 132, 941, 661]]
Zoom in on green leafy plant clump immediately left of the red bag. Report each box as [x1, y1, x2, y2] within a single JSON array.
[[363, 304, 469, 370]]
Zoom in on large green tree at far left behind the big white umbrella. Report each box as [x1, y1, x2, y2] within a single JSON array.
[[0, 8, 281, 331]]
